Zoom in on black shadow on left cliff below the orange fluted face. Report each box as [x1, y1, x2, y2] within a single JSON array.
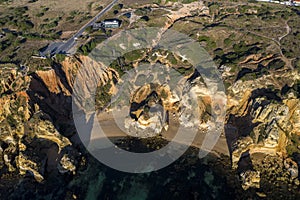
[[27, 64, 75, 136]]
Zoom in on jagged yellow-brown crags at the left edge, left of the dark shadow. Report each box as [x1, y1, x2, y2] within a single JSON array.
[[0, 68, 71, 182]]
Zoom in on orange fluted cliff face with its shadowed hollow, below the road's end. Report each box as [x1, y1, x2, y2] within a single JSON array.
[[28, 56, 119, 122]]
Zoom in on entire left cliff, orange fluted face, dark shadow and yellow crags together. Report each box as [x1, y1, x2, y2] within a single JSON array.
[[0, 56, 118, 182]]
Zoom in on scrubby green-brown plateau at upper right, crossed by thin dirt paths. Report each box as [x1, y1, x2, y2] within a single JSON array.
[[165, 1, 300, 88]]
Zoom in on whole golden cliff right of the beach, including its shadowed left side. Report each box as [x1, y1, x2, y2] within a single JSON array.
[[225, 70, 300, 189]]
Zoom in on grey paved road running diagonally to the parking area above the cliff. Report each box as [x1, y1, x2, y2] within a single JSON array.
[[41, 0, 118, 54]]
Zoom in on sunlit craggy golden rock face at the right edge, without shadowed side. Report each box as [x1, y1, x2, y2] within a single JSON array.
[[232, 94, 299, 168]]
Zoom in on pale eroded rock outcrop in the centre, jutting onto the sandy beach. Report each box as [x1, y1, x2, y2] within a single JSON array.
[[118, 65, 218, 137]]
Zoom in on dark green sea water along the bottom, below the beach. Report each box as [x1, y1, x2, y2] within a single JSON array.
[[1, 138, 295, 200]]
